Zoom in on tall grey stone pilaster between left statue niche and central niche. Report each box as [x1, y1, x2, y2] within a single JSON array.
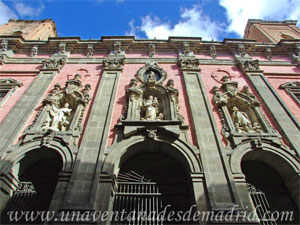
[[61, 57, 124, 211]]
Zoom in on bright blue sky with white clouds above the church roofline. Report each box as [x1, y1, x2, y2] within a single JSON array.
[[0, 0, 300, 41]]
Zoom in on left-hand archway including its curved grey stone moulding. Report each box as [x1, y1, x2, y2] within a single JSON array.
[[0, 140, 73, 220]]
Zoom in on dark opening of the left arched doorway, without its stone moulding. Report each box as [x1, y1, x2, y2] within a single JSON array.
[[1, 147, 62, 224]]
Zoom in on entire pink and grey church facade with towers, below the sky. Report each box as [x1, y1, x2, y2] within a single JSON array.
[[0, 20, 300, 225]]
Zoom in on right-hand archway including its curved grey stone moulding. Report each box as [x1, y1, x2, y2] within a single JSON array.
[[230, 140, 300, 224]]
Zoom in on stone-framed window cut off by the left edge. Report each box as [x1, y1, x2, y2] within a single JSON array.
[[0, 78, 22, 107]]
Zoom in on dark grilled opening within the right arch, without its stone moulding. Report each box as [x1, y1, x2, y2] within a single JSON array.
[[241, 161, 299, 225]]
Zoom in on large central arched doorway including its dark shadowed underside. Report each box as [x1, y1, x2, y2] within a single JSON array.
[[106, 141, 197, 224]]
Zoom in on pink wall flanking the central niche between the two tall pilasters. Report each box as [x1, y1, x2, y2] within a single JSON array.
[[108, 64, 196, 145]]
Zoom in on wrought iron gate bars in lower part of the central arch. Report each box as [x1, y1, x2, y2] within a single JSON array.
[[113, 171, 192, 225]]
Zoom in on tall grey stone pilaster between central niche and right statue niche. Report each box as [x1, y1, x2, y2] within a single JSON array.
[[179, 59, 240, 212]]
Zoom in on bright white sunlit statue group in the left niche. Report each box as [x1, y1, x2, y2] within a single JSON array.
[[42, 103, 72, 131]]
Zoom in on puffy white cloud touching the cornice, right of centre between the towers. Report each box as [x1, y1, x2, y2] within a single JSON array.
[[129, 6, 222, 40]]
